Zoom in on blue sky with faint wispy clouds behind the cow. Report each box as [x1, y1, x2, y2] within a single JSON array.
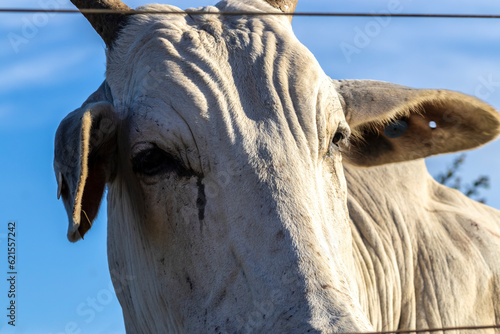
[[0, 0, 500, 334]]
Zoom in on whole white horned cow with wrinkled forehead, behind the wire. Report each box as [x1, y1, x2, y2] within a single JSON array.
[[54, 0, 500, 333]]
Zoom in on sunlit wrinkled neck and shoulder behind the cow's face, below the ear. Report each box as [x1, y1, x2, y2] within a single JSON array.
[[345, 160, 500, 328]]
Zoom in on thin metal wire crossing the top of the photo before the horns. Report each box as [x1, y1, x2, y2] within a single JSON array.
[[0, 8, 500, 19]]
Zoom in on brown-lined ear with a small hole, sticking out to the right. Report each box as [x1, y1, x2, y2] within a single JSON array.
[[335, 80, 500, 166]]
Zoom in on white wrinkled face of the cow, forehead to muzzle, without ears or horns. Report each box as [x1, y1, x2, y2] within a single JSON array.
[[107, 1, 371, 333]]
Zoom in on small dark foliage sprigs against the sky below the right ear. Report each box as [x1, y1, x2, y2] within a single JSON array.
[[435, 153, 490, 203]]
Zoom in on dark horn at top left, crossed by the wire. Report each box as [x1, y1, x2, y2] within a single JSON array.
[[71, 0, 131, 48]]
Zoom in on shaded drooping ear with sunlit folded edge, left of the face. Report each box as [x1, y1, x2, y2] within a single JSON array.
[[54, 83, 119, 242]]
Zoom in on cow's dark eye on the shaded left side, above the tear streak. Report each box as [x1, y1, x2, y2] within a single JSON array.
[[132, 145, 189, 176]]
